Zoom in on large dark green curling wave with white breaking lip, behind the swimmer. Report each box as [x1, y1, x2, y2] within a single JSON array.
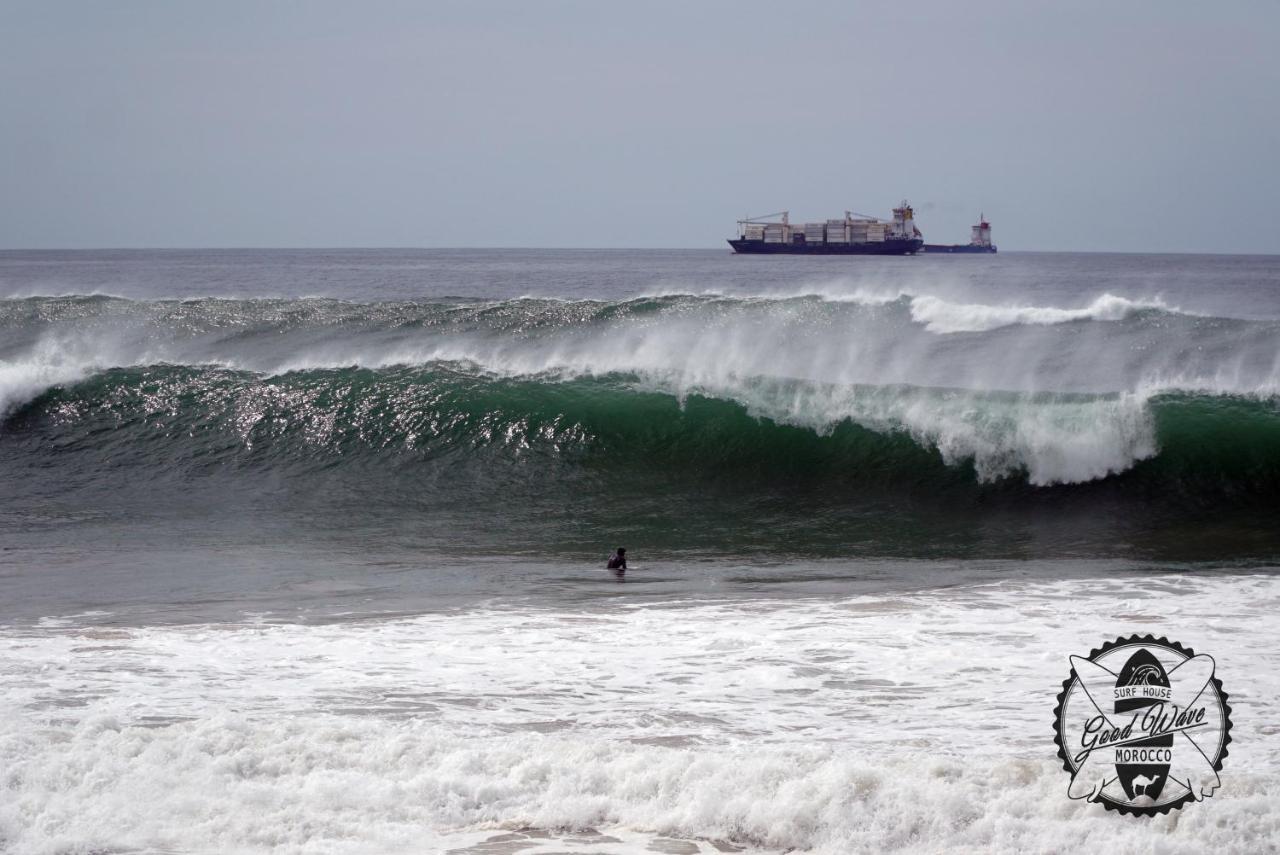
[[5, 362, 1280, 494]]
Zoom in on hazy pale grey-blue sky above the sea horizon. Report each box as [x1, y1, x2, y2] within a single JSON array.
[[0, 0, 1280, 252]]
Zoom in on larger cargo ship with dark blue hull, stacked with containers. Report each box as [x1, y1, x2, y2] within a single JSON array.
[[728, 201, 924, 255]]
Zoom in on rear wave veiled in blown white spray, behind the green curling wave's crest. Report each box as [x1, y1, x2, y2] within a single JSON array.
[[0, 294, 1280, 404]]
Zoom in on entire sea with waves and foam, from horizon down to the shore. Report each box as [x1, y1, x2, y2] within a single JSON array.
[[0, 250, 1280, 855]]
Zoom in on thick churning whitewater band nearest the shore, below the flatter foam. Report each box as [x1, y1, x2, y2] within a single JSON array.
[[0, 714, 1280, 855]]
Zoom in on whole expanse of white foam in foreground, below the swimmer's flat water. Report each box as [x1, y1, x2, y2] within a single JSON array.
[[0, 575, 1280, 855]]
